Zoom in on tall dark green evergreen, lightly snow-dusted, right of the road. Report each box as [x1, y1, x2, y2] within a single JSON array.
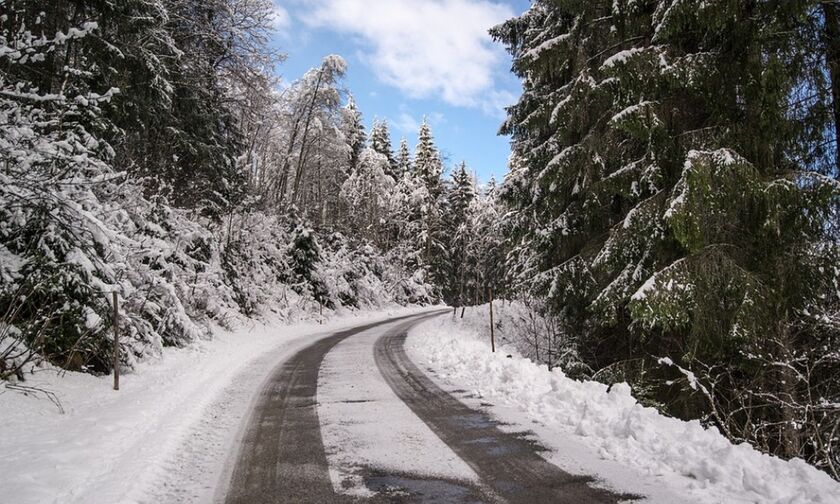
[[493, 0, 840, 464]]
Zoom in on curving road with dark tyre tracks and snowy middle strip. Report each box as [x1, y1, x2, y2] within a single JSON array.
[[220, 312, 632, 504]]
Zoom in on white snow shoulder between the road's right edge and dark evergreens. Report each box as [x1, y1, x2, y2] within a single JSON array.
[[407, 307, 840, 504]]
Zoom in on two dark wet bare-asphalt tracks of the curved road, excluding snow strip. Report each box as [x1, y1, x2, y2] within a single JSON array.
[[225, 310, 635, 504]]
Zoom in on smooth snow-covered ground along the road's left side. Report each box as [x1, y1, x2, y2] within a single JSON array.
[[0, 308, 434, 504]]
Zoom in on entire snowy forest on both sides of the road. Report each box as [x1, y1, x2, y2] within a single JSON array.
[[0, 0, 840, 479]]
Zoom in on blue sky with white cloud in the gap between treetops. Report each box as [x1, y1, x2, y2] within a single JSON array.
[[275, 0, 529, 181]]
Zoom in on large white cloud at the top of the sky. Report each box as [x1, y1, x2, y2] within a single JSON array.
[[301, 0, 513, 110]]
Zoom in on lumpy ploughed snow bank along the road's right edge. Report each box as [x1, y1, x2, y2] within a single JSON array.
[[410, 303, 840, 504]]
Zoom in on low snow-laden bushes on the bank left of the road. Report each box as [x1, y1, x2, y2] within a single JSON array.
[[0, 182, 434, 377]]
